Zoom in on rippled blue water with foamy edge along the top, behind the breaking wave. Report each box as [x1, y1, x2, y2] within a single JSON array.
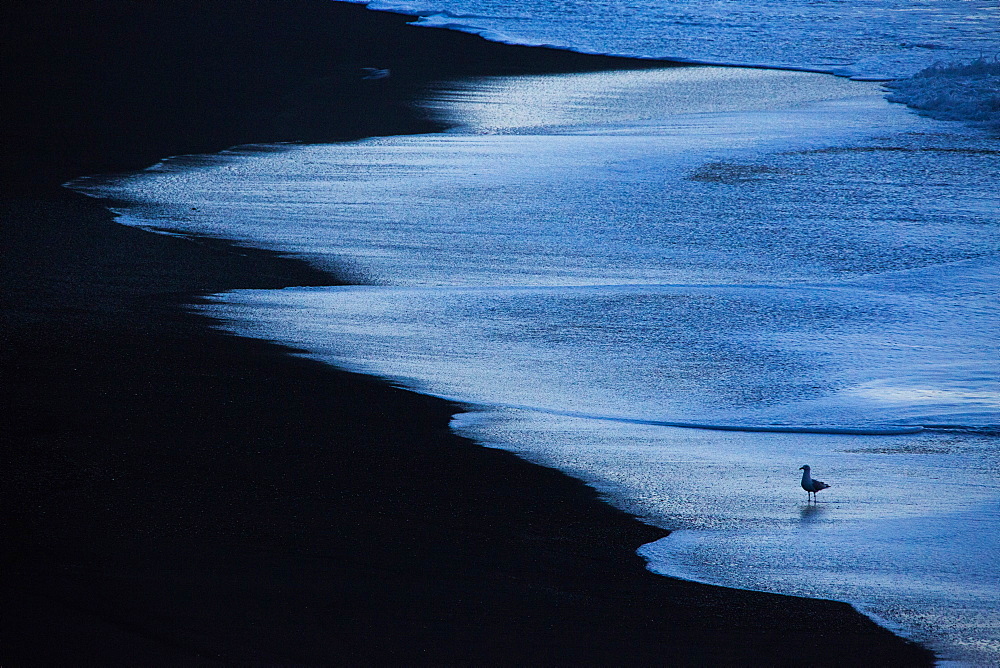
[[356, 0, 1000, 78]]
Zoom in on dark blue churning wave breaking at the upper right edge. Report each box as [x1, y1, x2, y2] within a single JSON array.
[[886, 58, 1000, 131]]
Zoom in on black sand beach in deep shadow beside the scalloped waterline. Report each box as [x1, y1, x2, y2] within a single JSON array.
[[0, 0, 933, 666]]
